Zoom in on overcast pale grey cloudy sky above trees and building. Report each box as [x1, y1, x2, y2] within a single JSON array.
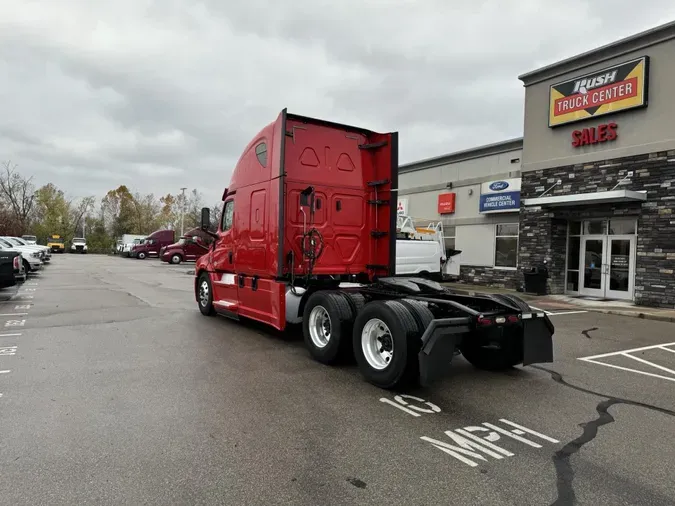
[[0, 0, 675, 201]]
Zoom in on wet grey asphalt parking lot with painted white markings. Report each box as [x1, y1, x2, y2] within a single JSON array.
[[0, 255, 675, 506]]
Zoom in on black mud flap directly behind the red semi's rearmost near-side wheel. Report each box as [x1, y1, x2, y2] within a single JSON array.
[[418, 318, 471, 387]]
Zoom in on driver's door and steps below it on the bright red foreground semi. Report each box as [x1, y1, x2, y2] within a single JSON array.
[[211, 198, 239, 314]]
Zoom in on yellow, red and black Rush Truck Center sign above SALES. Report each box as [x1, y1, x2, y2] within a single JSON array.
[[548, 56, 649, 127]]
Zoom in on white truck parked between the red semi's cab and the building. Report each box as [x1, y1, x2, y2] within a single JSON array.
[[396, 214, 461, 279]]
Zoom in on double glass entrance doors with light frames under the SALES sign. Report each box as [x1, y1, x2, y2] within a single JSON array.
[[579, 235, 635, 300]]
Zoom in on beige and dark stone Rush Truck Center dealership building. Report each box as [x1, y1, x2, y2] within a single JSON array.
[[399, 22, 675, 307]]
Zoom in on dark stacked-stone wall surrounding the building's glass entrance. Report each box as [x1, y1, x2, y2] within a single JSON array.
[[518, 151, 675, 308]]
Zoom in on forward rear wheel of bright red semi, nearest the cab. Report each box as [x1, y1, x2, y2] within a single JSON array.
[[302, 290, 354, 365]]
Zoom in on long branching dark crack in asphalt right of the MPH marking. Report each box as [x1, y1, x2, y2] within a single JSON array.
[[530, 365, 675, 506]]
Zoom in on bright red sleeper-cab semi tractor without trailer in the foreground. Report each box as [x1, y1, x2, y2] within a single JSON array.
[[194, 109, 554, 388]]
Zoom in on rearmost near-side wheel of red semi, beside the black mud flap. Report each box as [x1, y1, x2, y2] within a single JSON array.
[[352, 300, 421, 389]]
